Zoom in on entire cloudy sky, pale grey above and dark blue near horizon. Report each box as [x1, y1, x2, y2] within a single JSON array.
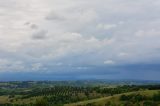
[[0, 0, 160, 80]]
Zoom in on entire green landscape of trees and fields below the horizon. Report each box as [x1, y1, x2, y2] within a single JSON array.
[[0, 81, 160, 106]]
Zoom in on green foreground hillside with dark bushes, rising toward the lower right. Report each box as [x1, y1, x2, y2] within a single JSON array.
[[64, 90, 160, 106]]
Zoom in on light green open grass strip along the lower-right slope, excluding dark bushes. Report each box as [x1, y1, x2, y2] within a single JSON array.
[[64, 90, 160, 106]]
